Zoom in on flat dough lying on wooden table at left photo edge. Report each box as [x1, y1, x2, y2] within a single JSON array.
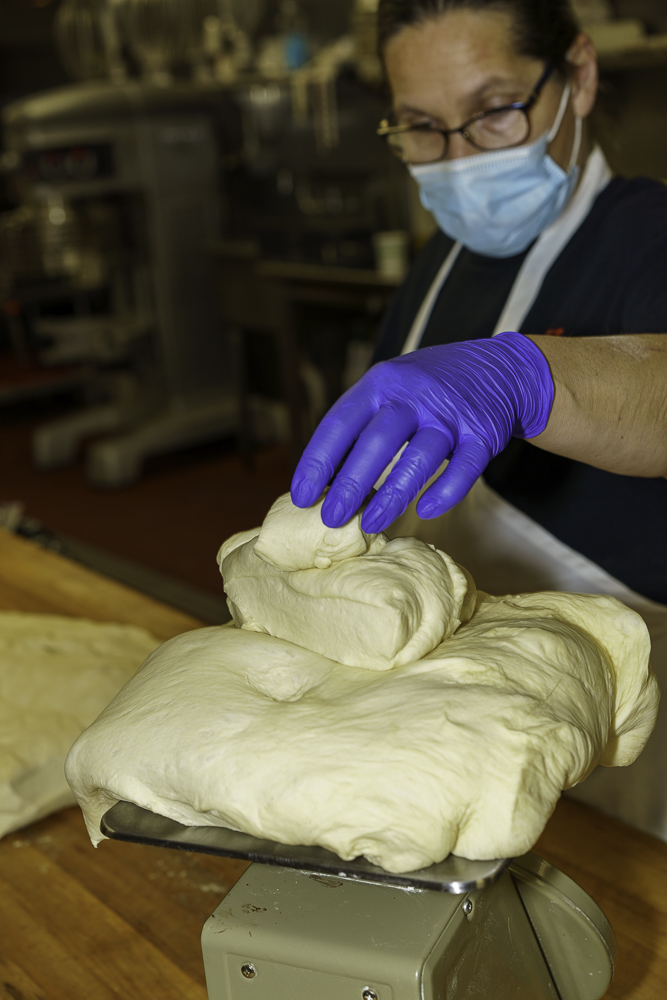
[[0, 611, 158, 837]]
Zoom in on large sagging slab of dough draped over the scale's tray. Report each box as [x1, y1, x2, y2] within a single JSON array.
[[67, 588, 659, 872]]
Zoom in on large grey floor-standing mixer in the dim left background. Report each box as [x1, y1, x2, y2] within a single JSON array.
[[2, 81, 238, 486]]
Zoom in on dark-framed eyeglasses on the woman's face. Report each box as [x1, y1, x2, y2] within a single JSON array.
[[377, 66, 554, 163]]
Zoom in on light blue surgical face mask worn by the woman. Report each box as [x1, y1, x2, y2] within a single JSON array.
[[409, 84, 581, 257]]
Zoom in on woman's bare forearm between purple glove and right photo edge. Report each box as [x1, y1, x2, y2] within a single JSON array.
[[530, 333, 667, 477]]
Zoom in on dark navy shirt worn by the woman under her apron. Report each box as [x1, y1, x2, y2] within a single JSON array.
[[375, 177, 667, 604]]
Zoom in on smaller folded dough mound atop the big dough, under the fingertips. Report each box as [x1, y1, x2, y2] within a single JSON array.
[[218, 495, 475, 670]]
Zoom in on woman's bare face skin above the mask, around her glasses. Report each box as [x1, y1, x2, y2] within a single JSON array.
[[384, 10, 597, 169]]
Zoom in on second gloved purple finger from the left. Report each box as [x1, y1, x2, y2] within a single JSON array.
[[322, 403, 417, 528]]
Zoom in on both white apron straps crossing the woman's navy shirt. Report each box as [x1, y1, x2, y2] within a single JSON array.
[[401, 146, 612, 354]]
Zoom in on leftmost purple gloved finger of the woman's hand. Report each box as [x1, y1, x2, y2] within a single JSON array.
[[291, 378, 379, 507]]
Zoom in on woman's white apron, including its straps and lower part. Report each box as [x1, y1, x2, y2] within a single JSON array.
[[388, 149, 667, 840]]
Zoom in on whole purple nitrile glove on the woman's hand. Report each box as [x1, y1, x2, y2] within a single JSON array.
[[292, 333, 554, 532]]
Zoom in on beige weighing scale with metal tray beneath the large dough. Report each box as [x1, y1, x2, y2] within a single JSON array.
[[101, 802, 616, 1000]]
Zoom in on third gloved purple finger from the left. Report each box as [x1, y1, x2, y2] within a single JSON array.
[[361, 427, 454, 533]]
